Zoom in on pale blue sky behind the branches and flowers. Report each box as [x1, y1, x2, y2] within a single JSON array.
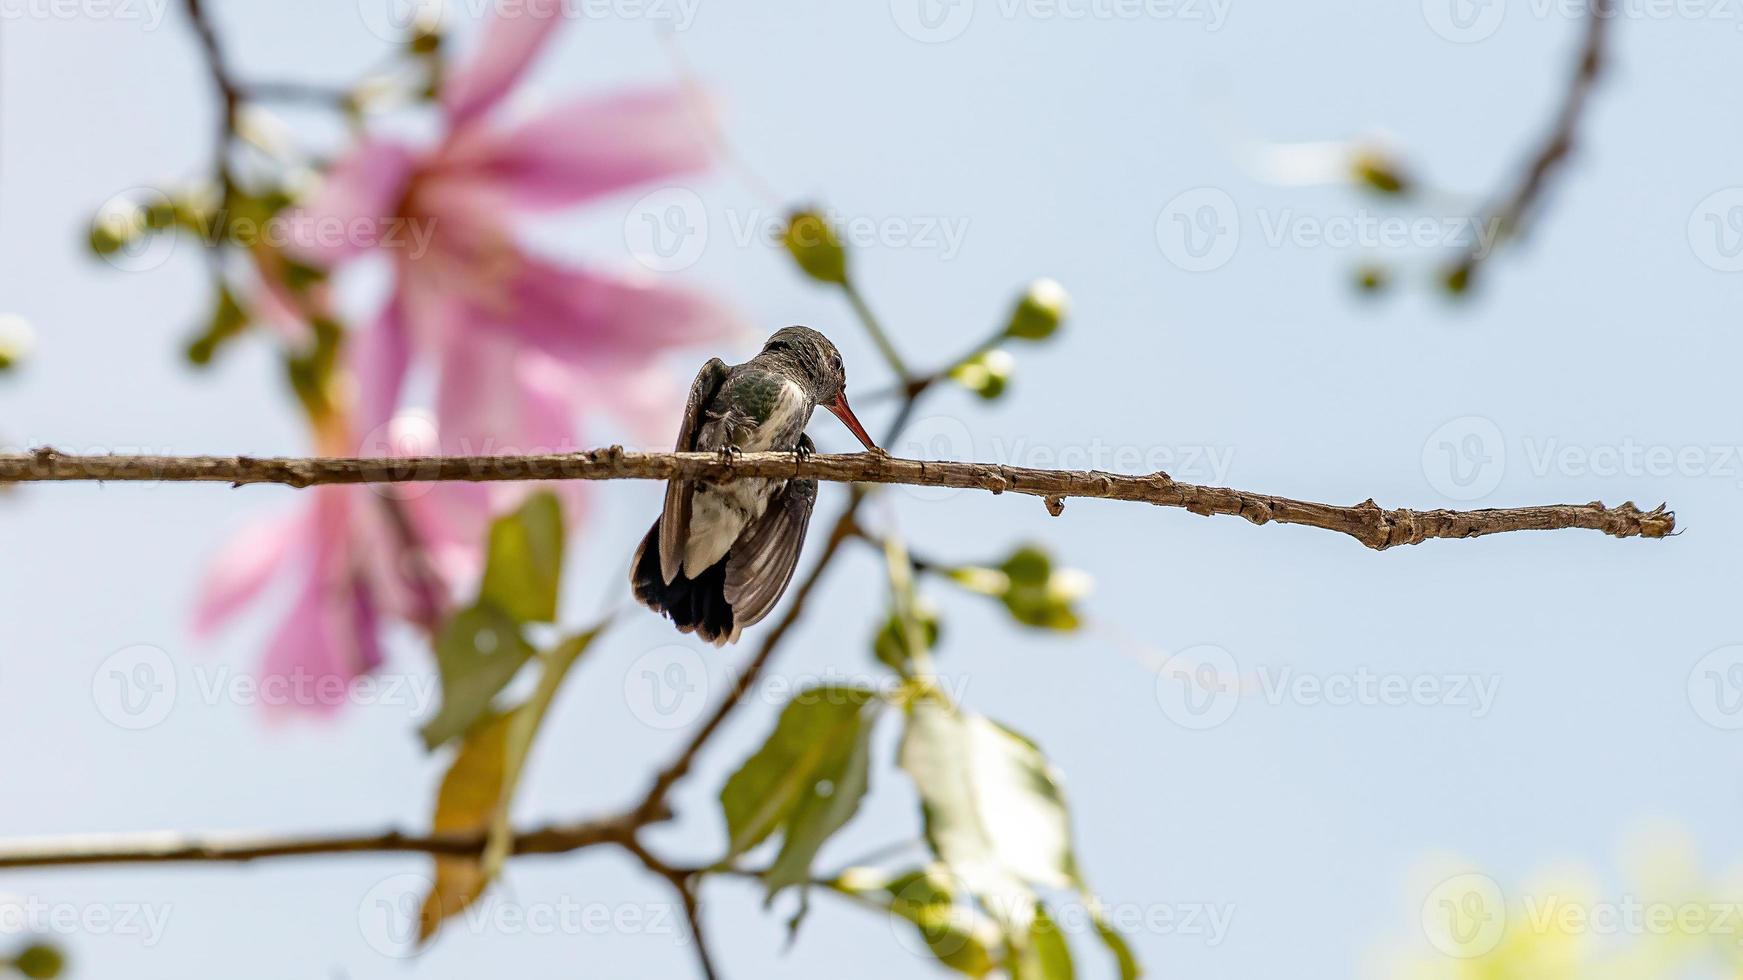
[[0, 0, 1743, 980]]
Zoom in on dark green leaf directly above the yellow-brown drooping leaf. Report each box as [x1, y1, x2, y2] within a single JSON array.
[[422, 605, 533, 748]]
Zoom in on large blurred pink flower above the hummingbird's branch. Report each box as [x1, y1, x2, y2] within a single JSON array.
[[291, 0, 737, 441]]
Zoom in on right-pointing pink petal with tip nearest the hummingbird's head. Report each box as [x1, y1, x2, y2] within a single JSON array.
[[502, 255, 743, 370]]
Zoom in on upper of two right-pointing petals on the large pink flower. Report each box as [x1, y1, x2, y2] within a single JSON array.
[[443, 89, 709, 208]]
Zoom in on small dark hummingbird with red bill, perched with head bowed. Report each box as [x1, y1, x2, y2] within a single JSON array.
[[629, 326, 880, 647]]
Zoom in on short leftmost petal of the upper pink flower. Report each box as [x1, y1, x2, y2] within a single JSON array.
[[286, 140, 418, 265]]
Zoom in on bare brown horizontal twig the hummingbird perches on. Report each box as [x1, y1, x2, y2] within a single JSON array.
[[0, 444, 1677, 549]]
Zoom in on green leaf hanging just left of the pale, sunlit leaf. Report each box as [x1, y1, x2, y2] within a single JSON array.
[[720, 685, 882, 896]]
